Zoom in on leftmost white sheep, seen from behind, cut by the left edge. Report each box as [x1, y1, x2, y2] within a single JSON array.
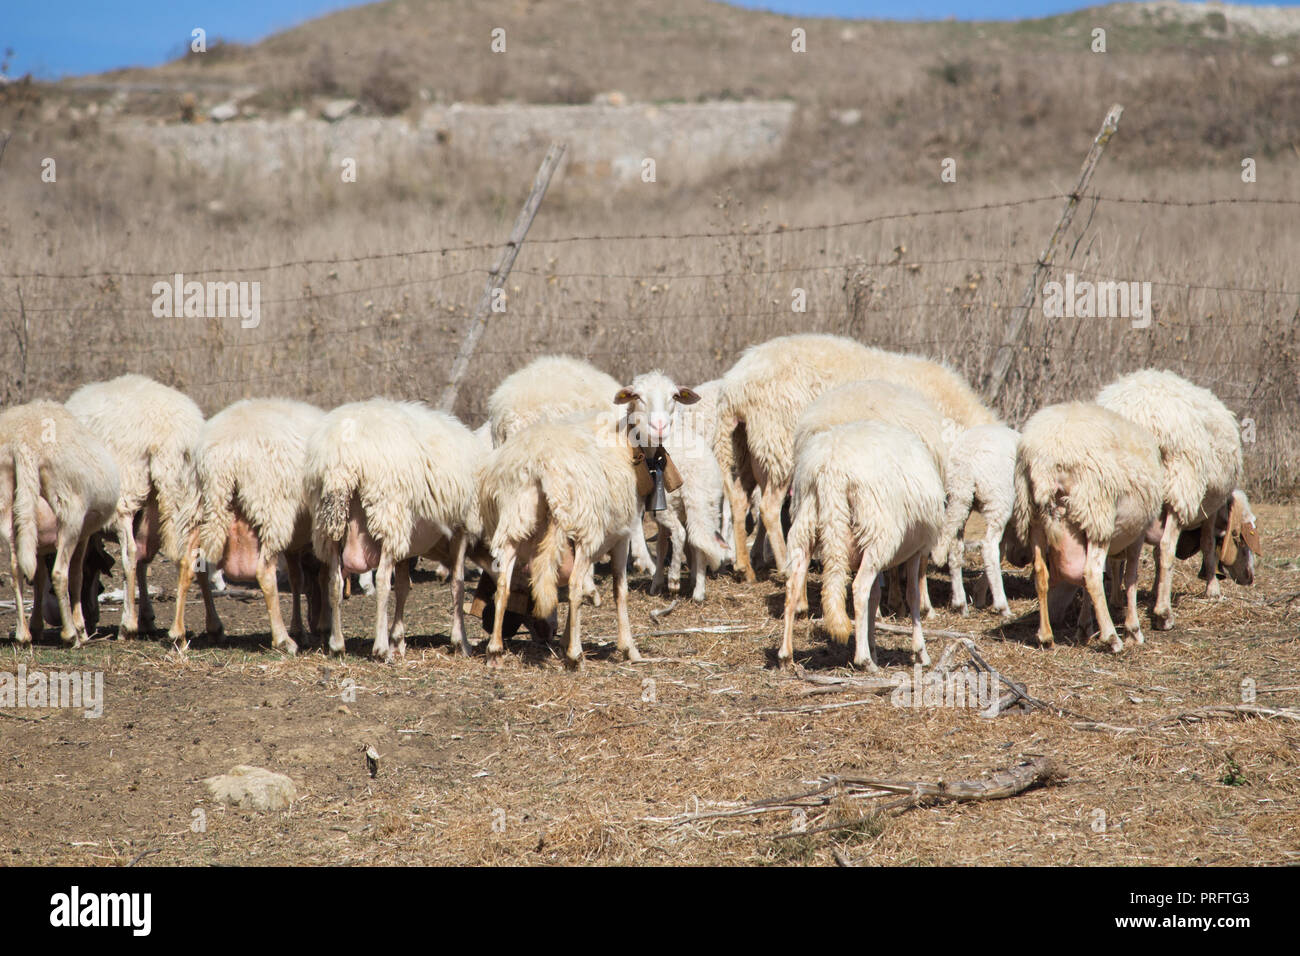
[[0, 402, 121, 646]]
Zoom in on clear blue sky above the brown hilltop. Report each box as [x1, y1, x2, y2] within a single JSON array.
[[0, 0, 1300, 79]]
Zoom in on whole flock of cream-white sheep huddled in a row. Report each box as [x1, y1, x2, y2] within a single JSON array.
[[0, 334, 1260, 670]]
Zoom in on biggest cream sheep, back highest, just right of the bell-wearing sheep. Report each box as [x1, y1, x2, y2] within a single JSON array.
[[715, 334, 997, 580]]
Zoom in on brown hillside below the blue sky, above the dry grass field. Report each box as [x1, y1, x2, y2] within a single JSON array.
[[35, 0, 1300, 189]]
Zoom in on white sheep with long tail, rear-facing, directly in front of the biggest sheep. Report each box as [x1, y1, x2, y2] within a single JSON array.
[[777, 420, 944, 671]]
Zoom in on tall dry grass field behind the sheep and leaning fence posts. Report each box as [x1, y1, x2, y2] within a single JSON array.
[[0, 129, 1300, 494]]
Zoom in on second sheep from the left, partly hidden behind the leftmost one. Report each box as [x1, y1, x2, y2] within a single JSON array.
[[65, 375, 208, 639]]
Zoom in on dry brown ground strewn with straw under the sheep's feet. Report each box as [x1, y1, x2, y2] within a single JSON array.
[[0, 505, 1300, 865]]
